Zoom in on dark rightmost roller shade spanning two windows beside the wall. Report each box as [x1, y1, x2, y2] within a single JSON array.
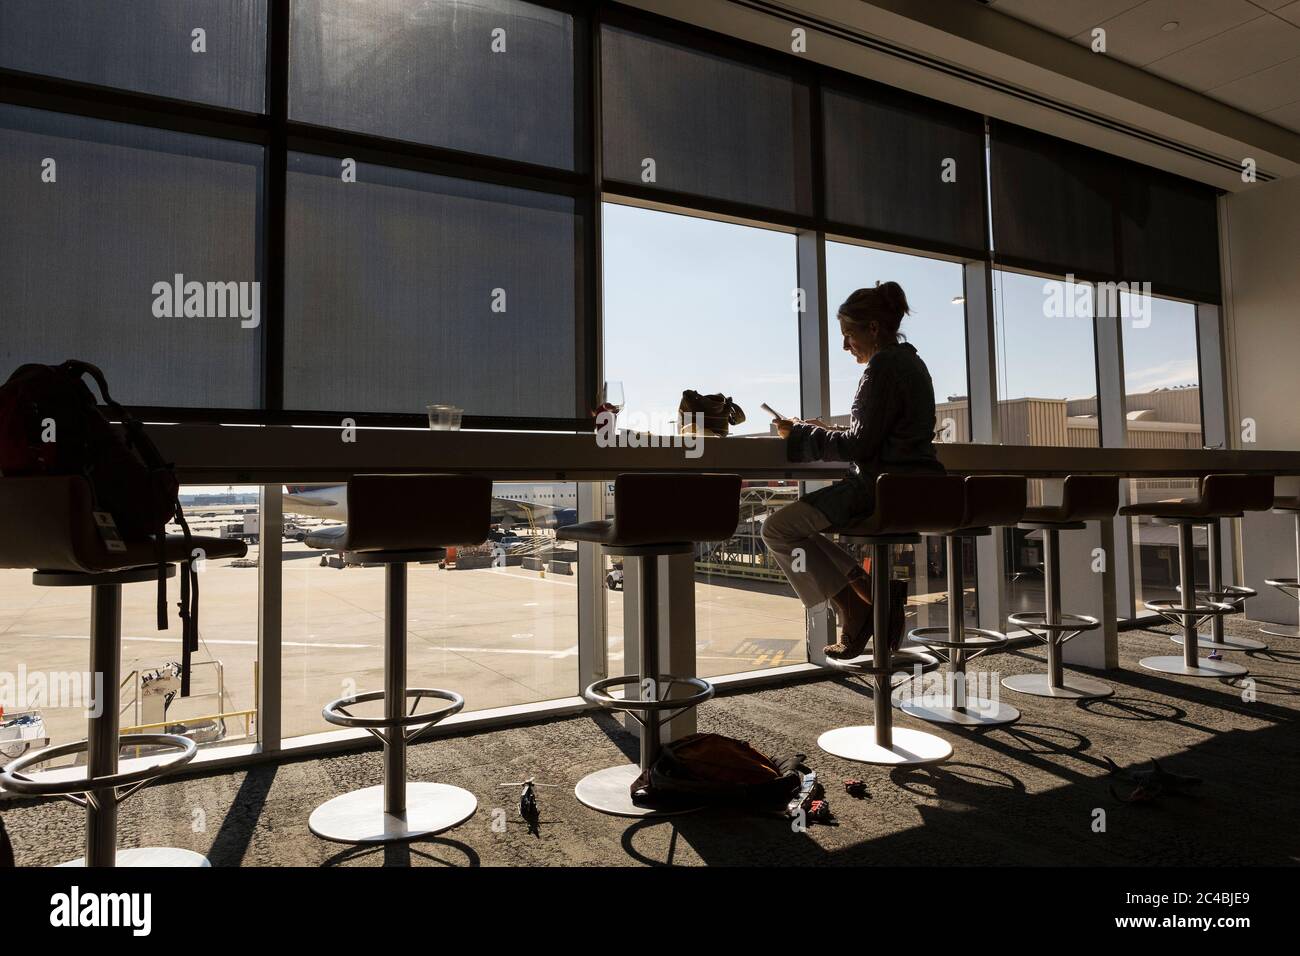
[[989, 121, 1221, 302]]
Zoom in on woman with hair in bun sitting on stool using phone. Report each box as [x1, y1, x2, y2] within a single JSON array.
[[763, 282, 944, 658]]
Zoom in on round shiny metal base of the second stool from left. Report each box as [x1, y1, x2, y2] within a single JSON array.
[[307, 783, 478, 843]]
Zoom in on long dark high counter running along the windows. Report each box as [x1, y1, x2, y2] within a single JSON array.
[[148, 424, 1300, 484]]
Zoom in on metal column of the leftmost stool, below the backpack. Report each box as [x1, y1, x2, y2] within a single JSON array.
[[86, 584, 122, 866]]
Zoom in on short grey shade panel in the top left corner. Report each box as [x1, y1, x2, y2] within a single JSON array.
[[0, 0, 267, 113]]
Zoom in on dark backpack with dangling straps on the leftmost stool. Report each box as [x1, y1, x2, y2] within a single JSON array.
[[0, 359, 199, 696]]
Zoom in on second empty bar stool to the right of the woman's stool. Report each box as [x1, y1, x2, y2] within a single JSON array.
[[1002, 475, 1119, 700]]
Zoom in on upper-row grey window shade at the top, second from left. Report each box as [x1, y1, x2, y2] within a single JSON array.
[[297, 0, 575, 169]]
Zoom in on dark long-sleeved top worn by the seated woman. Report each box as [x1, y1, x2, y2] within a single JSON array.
[[787, 342, 944, 483]]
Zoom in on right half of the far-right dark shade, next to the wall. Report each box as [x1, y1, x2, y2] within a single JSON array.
[[1119, 163, 1222, 302]]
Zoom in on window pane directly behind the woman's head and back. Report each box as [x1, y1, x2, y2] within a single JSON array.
[[826, 242, 971, 441]]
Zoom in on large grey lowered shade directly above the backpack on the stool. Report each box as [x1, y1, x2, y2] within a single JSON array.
[[0, 105, 263, 408]]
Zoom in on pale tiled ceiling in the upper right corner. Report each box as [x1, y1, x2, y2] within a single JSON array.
[[987, 0, 1300, 133]]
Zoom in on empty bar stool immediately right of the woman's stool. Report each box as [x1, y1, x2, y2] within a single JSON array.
[[898, 475, 1027, 727]]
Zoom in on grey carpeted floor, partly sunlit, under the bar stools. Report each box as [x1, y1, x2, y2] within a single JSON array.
[[4, 622, 1300, 866]]
